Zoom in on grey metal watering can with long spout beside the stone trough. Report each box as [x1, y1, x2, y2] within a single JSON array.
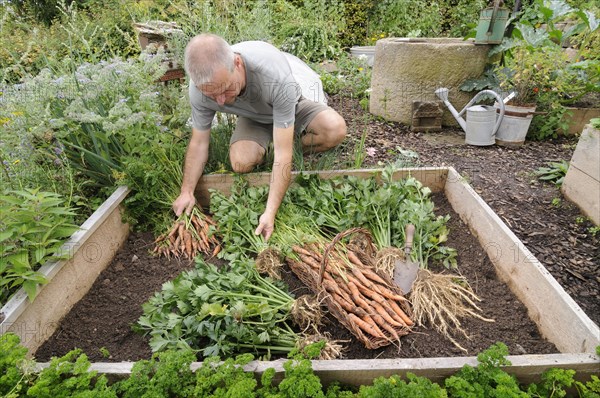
[[435, 87, 504, 146]]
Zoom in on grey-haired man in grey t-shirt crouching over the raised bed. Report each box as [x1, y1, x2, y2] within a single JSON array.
[[173, 34, 346, 239]]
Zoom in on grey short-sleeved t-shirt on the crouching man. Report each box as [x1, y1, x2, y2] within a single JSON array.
[[189, 41, 326, 130]]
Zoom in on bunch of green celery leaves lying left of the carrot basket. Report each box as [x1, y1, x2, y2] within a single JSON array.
[[136, 258, 298, 357]]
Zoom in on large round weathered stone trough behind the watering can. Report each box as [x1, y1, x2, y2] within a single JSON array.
[[369, 37, 490, 126]]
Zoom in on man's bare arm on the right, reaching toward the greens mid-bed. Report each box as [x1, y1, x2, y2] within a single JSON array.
[[254, 125, 294, 240]]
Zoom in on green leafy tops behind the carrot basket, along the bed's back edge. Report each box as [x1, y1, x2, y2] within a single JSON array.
[[211, 167, 456, 268]]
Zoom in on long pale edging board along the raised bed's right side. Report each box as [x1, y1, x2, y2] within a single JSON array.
[[446, 168, 600, 353]]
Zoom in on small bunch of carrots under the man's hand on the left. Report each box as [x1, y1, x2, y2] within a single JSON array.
[[154, 207, 221, 260]]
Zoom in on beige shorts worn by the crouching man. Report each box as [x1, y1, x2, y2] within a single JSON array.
[[229, 97, 331, 149]]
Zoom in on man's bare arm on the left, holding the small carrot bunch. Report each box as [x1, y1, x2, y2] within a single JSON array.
[[173, 127, 210, 216]]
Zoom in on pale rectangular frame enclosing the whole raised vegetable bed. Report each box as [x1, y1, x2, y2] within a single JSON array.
[[1, 167, 600, 385]]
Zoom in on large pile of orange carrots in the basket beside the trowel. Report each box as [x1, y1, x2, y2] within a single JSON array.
[[287, 239, 414, 349]]
